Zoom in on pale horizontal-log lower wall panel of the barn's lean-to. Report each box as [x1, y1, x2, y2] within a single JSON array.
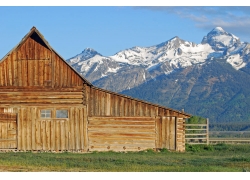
[[88, 117, 156, 151]]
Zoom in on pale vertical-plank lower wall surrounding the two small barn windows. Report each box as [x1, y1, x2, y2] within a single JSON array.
[[14, 106, 87, 151]]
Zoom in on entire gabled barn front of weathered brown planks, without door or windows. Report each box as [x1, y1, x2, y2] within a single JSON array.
[[0, 32, 88, 151]]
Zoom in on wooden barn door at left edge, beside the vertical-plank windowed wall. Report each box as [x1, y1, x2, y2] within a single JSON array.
[[0, 113, 17, 149]]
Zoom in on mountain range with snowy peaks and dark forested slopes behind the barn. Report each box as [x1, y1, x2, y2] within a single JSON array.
[[67, 27, 250, 122]]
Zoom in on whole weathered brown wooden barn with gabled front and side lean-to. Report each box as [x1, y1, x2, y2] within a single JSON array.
[[0, 27, 190, 151]]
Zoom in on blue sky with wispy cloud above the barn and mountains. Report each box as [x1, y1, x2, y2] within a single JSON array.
[[0, 1, 250, 59]]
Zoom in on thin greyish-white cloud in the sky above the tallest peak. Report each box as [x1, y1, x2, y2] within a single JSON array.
[[139, 6, 250, 41]]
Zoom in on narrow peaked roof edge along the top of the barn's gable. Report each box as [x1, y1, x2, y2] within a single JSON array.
[[0, 26, 93, 86]]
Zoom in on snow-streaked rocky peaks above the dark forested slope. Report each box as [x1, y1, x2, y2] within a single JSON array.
[[67, 27, 250, 92]]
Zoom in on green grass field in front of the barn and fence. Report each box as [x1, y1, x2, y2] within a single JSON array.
[[0, 144, 250, 172]]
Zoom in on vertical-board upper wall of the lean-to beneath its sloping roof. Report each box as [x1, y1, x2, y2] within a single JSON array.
[[85, 86, 184, 117]]
